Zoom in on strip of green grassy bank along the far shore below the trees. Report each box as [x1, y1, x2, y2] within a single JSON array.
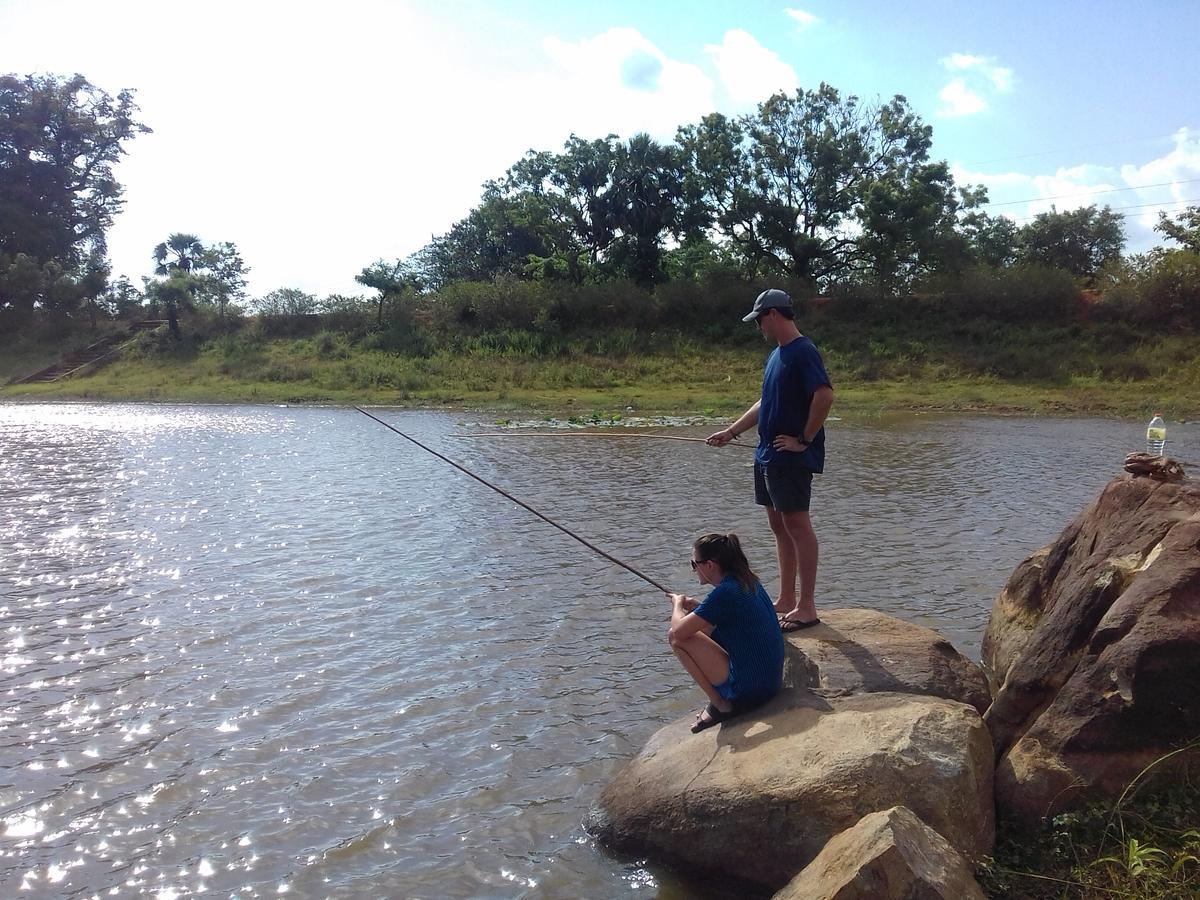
[[0, 329, 1200, 420]]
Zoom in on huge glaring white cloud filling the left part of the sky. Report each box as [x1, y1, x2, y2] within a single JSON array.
[[0, 0, 716, 295]]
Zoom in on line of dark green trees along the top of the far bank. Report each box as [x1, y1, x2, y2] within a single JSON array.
[[0, 74, 1200, 343]]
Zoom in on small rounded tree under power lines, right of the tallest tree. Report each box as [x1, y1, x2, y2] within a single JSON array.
[[1018, 205, 1126, 283]]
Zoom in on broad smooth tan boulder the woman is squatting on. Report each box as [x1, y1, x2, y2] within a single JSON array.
[[588, 691, 995, 889]]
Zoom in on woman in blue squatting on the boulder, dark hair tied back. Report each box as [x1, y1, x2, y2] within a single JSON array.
[[667, 534, 784, 732]]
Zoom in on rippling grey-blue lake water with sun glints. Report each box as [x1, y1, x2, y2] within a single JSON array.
[[0, 404, 1185, 900]]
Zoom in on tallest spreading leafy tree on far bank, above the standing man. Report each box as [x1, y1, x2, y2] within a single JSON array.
[[678, 84, 962, 286]]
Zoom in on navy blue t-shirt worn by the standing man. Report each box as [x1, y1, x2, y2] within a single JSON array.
[[755, 335, 829, 473]]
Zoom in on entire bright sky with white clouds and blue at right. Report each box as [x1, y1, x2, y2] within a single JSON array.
[[0, 0, 1200, 294]]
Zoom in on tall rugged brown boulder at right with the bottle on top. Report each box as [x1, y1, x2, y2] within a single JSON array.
[[983, 468, 1200, 821]]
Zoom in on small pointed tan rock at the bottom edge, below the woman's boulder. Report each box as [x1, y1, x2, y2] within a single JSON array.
[[774, 806, 984, 900]]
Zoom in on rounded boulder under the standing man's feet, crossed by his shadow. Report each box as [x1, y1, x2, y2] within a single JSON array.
[[784, 610, 991, 715]]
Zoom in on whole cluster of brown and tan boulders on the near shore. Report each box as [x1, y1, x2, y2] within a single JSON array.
[[588, 455, 1200, 900]]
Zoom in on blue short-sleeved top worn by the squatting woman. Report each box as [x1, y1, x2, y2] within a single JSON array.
[[696, 575, 784, 703]]
